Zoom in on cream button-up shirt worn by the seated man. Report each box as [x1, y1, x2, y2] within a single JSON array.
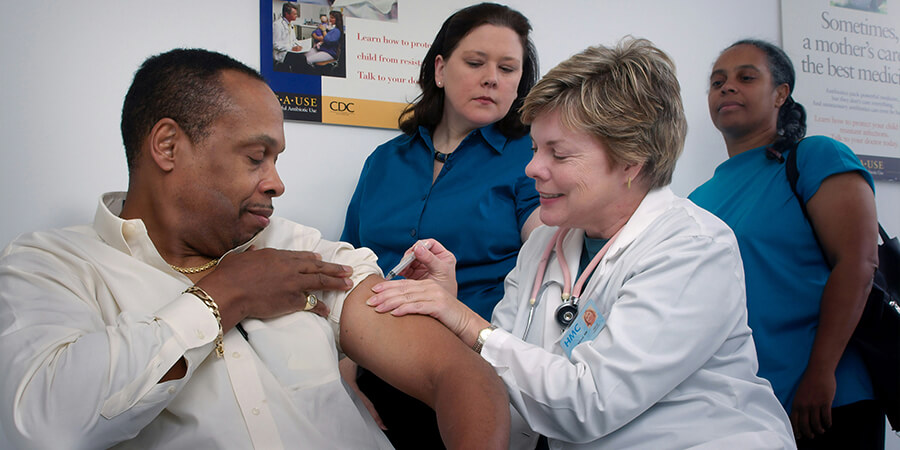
[[0, 193, 390, 449]]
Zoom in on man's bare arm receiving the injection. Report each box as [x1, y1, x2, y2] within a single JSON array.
[[341, 275, 509, 449]]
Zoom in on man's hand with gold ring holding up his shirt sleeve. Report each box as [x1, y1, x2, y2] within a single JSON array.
[[197, 247, 353, 331]]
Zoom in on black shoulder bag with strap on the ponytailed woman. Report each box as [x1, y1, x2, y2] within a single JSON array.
[[785, 144, 900, 431]]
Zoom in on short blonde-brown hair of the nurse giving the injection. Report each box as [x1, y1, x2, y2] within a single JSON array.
[[521, 36, 687, 189]]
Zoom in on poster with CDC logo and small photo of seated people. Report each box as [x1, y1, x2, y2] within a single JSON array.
[[260, 0, 467, 128]]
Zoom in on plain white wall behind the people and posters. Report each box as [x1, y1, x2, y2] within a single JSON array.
[[0, 0, 900, 442]]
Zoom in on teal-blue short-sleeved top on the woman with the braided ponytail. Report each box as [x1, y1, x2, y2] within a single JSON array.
[[688, 136, 874, 413]]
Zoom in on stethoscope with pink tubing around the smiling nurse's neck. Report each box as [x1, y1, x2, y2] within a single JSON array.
[[522, 228, 621, 339]]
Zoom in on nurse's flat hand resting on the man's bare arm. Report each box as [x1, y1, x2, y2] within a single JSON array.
[[366, 279, 490, 346]]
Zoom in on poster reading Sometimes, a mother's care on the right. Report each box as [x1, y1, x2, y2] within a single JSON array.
[[781, 0, 900, 182]]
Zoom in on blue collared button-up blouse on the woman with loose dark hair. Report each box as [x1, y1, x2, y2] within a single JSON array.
[[341, 125, 539, 320]]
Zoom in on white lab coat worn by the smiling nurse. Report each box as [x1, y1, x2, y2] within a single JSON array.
[[482, 188, 795, 450]]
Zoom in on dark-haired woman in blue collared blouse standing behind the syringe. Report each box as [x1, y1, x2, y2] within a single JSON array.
[[341, 3, 540, 448]]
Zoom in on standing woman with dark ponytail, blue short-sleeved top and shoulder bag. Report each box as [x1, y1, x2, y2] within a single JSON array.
[[690, 40, 884, 449]]
